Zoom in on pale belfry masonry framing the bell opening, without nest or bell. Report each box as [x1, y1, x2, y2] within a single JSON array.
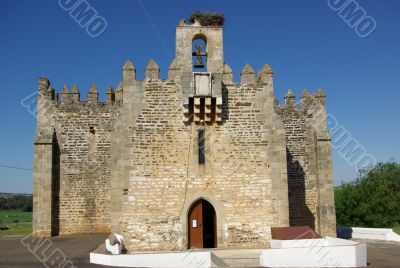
[[175, 20, 224, 122]]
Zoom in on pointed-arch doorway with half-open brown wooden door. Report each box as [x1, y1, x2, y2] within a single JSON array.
[[187, 199, 217, 248]]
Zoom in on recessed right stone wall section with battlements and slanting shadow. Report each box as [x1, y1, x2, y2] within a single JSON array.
[[277, 90, 336, 236]]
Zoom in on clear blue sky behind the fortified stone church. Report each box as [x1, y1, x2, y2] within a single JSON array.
[[0, 0, 400, 193]]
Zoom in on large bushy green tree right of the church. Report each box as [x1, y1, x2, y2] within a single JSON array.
[[335, 162, 400, 227]]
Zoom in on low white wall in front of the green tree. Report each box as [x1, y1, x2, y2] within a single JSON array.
[[337, 227, 400, 242]]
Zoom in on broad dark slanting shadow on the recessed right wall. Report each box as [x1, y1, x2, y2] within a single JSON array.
[[286, 148, 315, 230]]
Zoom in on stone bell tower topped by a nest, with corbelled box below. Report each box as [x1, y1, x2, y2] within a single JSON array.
[[176, 13, 224, 122]]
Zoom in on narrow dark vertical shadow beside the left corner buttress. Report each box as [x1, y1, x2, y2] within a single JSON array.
[[51, 133, 61, 236]]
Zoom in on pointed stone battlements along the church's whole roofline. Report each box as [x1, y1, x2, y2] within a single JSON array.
[[39, 59, 326, 123]]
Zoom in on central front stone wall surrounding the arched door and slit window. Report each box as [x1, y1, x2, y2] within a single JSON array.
[[112, 61, 289, 251]]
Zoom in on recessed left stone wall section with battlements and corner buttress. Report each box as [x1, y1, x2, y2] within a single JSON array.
[[34, 78, 120, 235]]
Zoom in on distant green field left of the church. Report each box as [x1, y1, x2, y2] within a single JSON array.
[[0, 210, 32, 236]]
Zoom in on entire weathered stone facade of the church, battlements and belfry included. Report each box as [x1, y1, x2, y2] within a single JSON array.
[[33, 16, 335, 251]]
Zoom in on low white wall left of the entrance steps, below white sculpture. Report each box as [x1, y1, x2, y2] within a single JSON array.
[[90, 252, 211, 268]]
